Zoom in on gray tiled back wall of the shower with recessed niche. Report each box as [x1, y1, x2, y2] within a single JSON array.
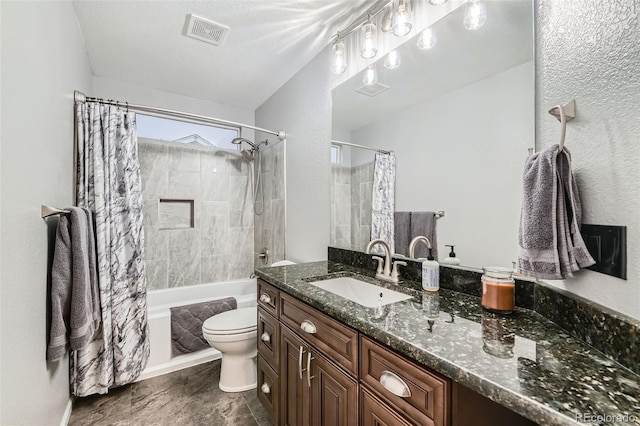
[[138, 138, 254, 290]]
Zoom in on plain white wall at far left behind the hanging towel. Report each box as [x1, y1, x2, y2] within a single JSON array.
[[0, 1, 91, 425]]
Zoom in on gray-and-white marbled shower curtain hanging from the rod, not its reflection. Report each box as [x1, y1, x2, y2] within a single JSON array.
[[70, 102, 149, 396]]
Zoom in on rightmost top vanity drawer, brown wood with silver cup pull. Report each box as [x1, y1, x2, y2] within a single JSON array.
[[360, 337, 451, 426]]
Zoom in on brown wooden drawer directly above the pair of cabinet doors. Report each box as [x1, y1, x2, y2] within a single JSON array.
[[280, 293, 358, 375]]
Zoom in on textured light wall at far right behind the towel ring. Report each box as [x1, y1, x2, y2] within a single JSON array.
[[536, 0, 640, 318]]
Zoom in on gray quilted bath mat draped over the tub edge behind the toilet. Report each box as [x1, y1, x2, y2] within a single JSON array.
[[171, 297, 238, 356]]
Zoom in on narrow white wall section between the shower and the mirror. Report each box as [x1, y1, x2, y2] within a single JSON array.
[[256, 48, 343, 262]]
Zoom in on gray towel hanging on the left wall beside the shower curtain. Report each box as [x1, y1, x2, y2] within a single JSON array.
[[47, 207, 101, 361]]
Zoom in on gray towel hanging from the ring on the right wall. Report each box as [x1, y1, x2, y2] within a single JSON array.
[[518, 145, 595, 279]]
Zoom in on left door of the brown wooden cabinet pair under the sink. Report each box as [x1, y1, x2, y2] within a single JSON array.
[[280, 326, 310, 426]]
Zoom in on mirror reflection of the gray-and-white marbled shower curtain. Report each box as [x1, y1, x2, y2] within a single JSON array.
[[371, 153, 396, 253]]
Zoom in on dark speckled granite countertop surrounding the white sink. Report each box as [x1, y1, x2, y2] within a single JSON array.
[[256, 261, 640, 425]]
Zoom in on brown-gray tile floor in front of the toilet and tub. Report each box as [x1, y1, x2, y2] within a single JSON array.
[[69, 360, 272, 426]]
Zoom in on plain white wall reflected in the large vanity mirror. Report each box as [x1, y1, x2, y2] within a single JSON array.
[[351, 62, 534, 267]]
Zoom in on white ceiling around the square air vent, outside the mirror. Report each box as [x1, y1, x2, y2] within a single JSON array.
[[73, 0, 374, 110]]
